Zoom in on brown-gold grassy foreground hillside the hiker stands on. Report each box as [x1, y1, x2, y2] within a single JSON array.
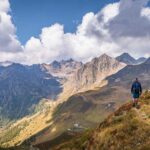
[[53, 92, 150, 150]]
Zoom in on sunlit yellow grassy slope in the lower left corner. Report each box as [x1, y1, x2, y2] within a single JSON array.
[[0, 100, 53, 147]]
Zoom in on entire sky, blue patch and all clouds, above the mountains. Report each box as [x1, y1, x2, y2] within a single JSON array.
[[0, 0, 150, 65]]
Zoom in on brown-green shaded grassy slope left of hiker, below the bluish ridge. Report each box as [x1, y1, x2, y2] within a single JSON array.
[[34, 82, 130, 144]]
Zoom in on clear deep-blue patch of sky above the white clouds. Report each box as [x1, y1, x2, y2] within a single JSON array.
[[10, 0, 118, 44]]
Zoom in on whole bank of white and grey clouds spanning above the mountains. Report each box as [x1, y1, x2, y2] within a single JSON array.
[[0, 0, 150, 64]]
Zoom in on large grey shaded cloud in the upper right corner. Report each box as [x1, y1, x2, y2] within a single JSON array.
[[108, 0, 150, 57]]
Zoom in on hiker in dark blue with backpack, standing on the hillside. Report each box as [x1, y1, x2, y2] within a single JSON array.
[[131, 78, 142, 107]]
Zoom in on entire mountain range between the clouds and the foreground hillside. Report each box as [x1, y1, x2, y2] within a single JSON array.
[[0, 53, 150, 149]]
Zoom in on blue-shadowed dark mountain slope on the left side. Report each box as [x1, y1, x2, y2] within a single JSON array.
[[0, 64, 62, 124]]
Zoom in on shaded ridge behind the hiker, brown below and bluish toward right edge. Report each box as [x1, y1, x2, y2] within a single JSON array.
[[30, 54, 150, 149]]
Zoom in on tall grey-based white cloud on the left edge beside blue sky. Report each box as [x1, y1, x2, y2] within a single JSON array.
[[0, 0, 22, 52]]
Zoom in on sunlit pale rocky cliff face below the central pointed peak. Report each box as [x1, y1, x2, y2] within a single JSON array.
[[75, 54, 125, 89]]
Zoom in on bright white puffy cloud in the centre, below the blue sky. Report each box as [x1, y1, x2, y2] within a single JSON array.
[[24, 3, 119, 64]]
